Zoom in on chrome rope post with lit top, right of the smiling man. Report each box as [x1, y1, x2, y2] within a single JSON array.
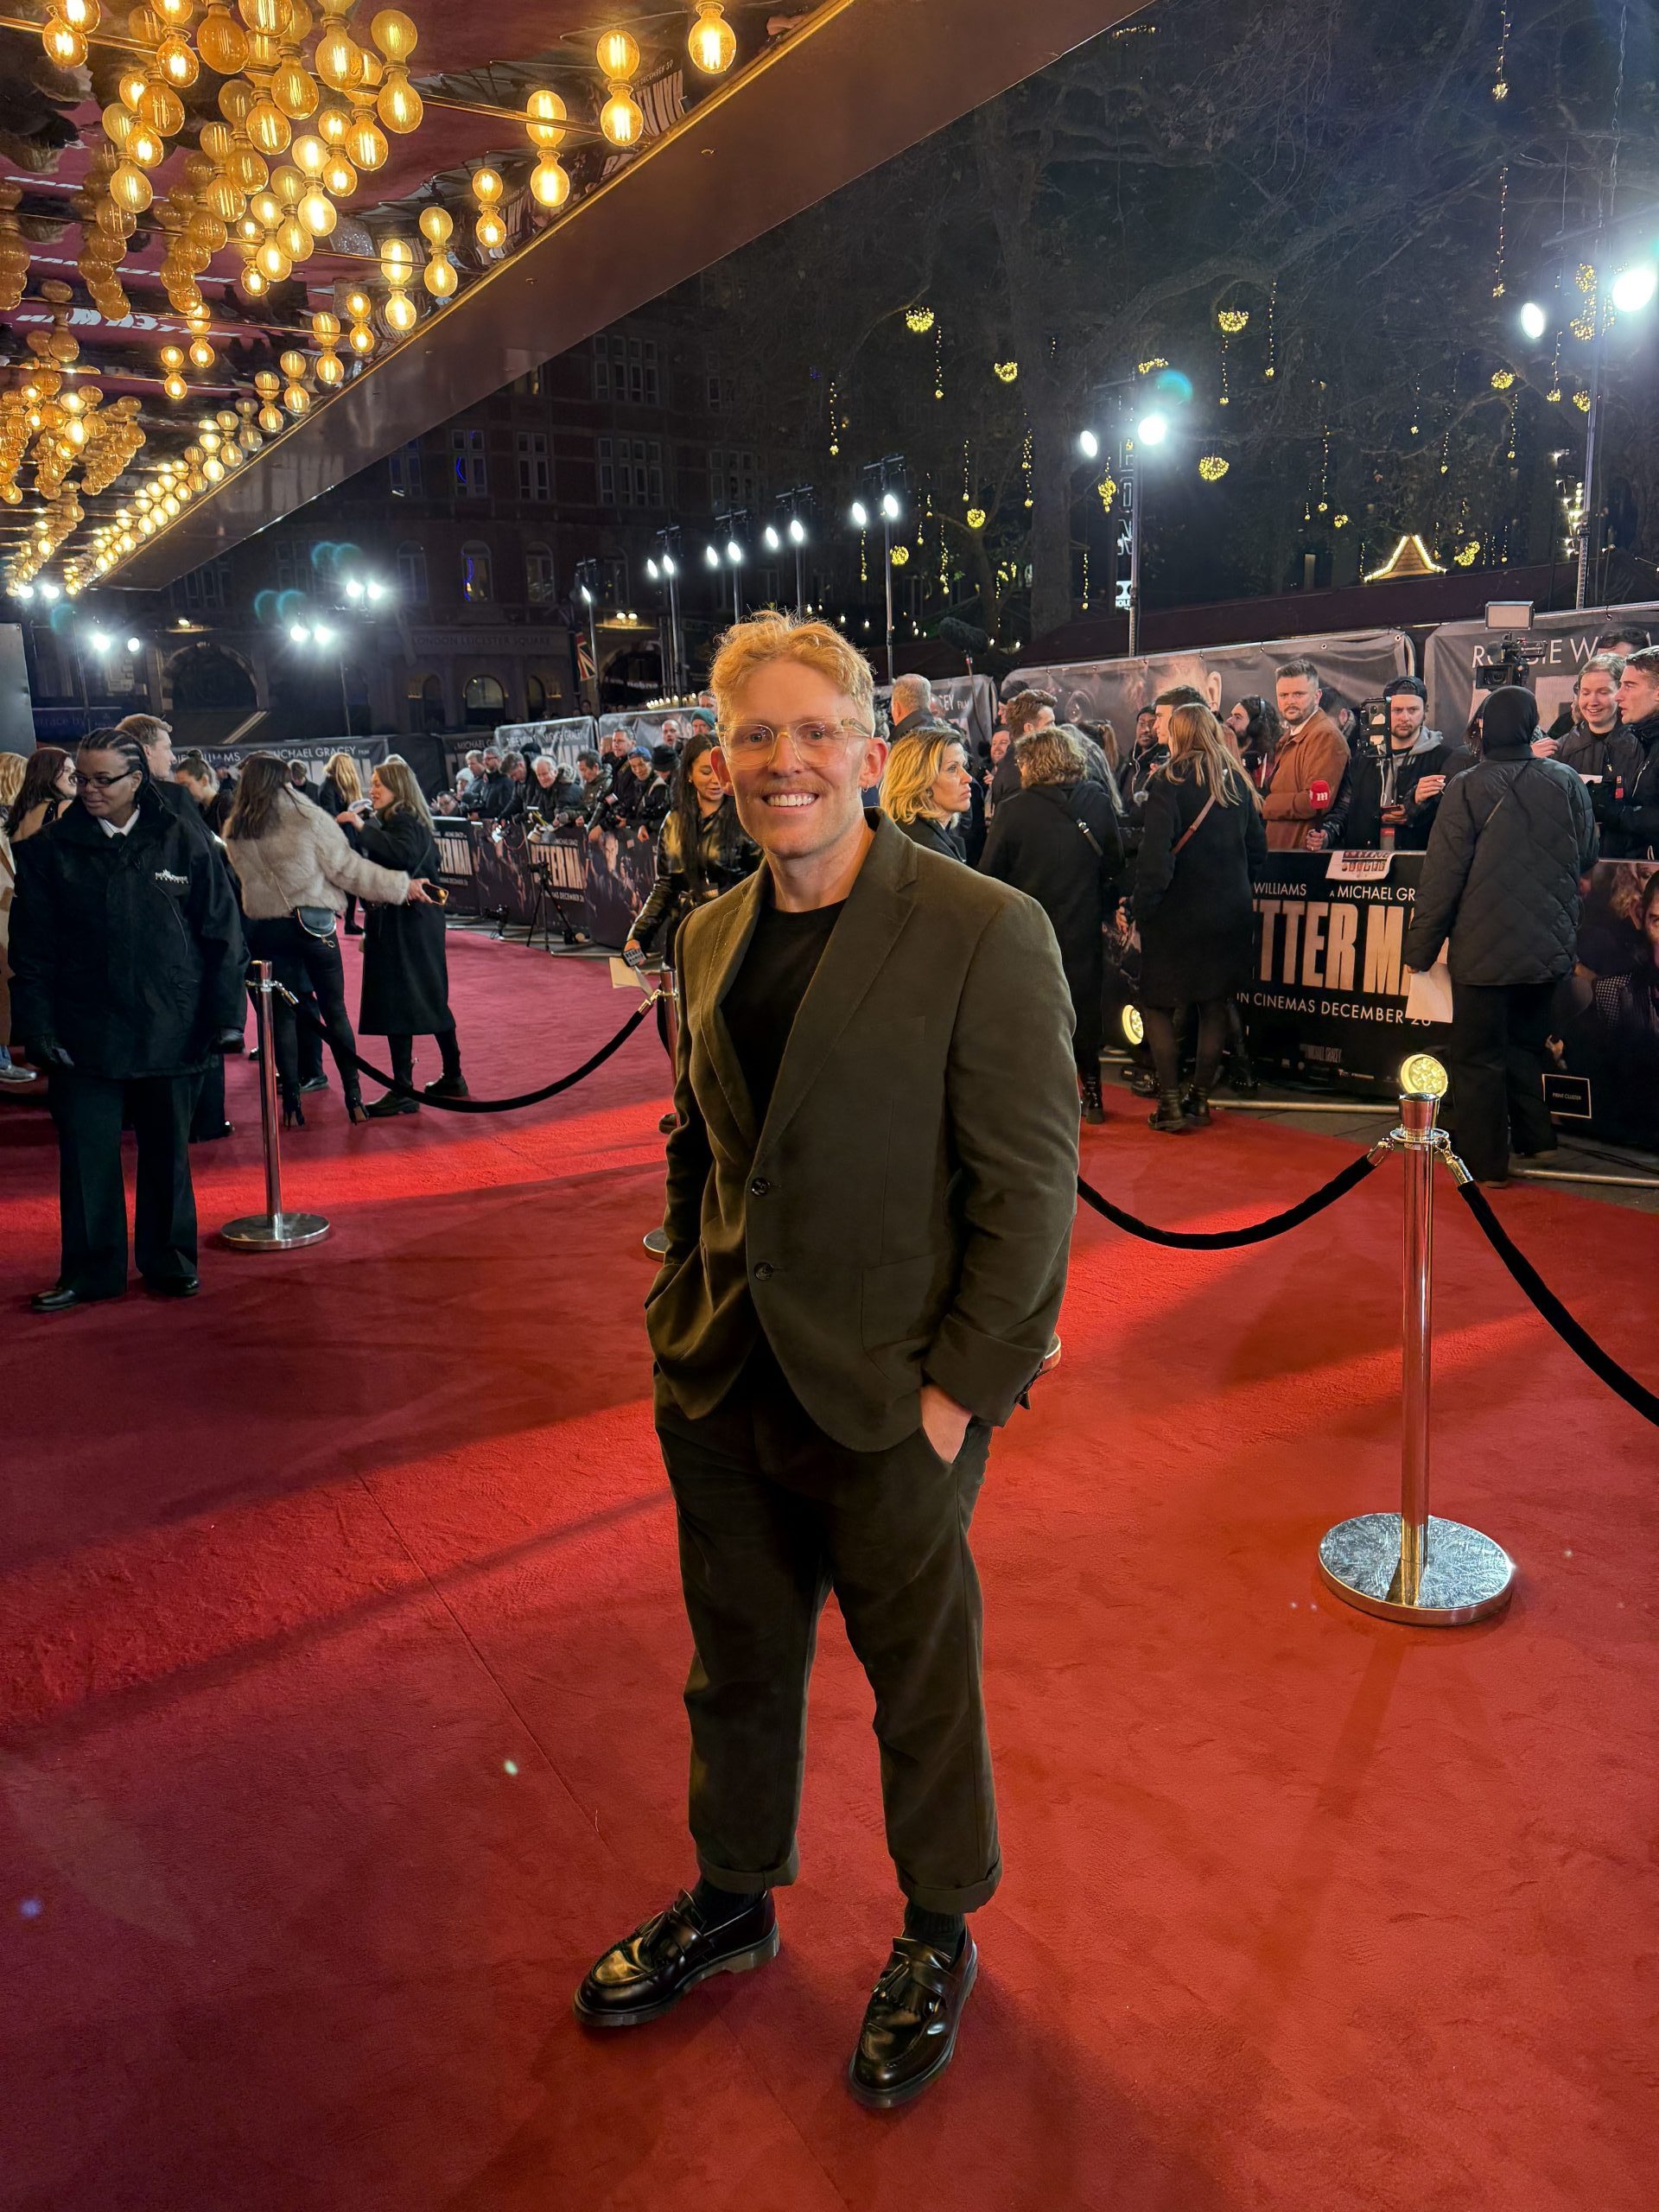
[[1319, 1053, 1516, 1628]]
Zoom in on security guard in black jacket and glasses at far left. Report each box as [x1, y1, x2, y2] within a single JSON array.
[[11, 730, 248, 1314]]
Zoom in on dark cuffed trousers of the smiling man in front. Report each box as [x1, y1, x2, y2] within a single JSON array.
[[657, 1344, 1002, 1913]]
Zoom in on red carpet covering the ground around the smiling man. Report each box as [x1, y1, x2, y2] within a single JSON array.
[[0, 938, 1659, 2212]]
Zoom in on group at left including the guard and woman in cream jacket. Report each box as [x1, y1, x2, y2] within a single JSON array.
[[0, 715, 467, 1314]]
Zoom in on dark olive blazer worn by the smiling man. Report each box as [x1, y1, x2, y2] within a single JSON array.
[[646, 817, 1092, 1451]]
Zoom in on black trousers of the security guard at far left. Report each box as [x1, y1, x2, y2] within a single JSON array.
[[51, 1068, 201, 1296]]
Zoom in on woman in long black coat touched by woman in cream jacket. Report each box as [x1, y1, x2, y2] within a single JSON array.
[[340, 752, 467, 1122]]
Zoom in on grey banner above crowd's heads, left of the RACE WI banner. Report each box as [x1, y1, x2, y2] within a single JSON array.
[[1002, 631, 1411, 750]]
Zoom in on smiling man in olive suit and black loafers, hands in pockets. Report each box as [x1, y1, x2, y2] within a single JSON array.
[[575, 615, 1077, 2106]]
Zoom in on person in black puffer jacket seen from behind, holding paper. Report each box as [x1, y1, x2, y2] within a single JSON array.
[[1405, 683, 1597, 1185]]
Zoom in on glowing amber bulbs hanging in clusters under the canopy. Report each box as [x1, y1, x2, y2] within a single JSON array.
[[0, 0, 736, 597]]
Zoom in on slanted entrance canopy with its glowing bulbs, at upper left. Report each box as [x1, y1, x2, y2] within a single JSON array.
[[0, 0, 1133, 595]]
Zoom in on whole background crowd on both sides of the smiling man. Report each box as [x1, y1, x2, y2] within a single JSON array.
[[0, 635, 1659, 1310]]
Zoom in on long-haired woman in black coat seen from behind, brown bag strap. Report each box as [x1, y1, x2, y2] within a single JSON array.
[[1135, 706, 1268, 1137]]
